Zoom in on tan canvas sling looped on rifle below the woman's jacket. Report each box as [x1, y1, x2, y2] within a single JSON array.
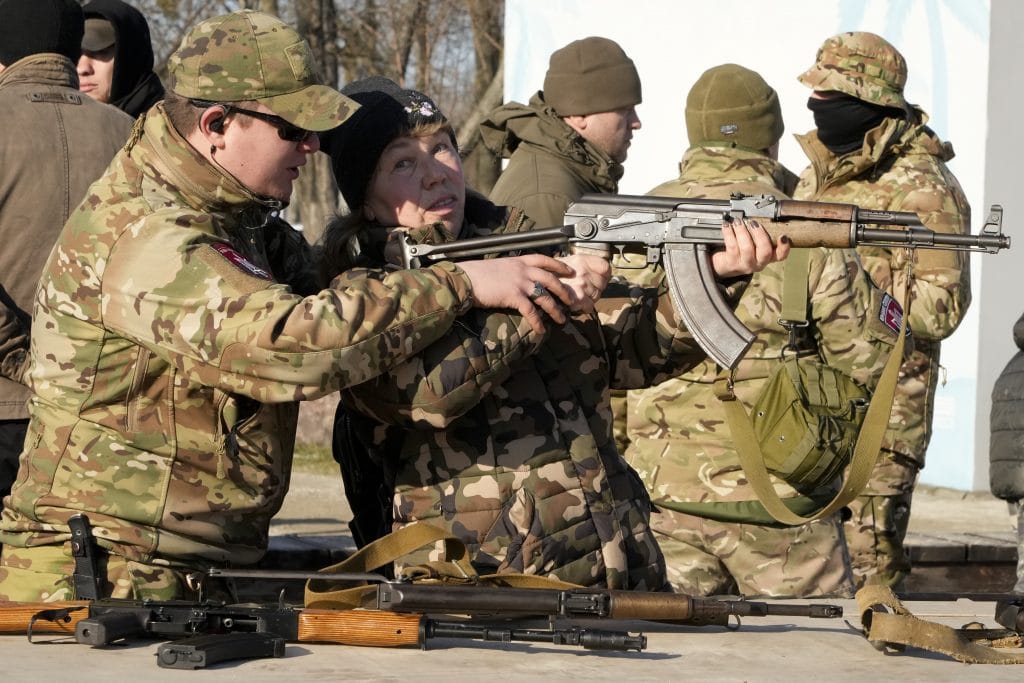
[[304, 522, 580, 609]]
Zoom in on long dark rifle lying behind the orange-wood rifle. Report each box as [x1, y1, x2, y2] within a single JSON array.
[[208, 569, 843, 627]]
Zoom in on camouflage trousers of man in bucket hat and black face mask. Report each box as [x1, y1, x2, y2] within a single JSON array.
[[843, 451, 920, 589]]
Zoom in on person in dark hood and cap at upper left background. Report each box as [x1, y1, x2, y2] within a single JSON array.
[[78, 0, 164, 119]]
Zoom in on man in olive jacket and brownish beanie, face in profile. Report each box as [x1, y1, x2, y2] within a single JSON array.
[[480, 37, 641, 227]]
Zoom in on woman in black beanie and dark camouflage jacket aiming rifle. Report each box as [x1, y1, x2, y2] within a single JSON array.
[[323, 78, 771, 590]]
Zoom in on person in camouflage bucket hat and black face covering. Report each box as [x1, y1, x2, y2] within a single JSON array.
[[795, 33, 971, 585]]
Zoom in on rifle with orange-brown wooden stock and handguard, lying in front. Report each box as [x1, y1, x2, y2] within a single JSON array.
[[0, 599, 647, 668]]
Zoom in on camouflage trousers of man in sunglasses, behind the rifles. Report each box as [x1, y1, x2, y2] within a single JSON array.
[[0, 545, 223, 602]]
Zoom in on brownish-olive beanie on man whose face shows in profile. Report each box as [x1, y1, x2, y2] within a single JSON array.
[[544, 36, 642, 116]]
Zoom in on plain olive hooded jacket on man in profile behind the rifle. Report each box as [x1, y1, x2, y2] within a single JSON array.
[[480, 92, 623, 227]]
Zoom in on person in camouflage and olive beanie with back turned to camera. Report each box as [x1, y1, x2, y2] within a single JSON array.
[[626, 65, 896, 597]]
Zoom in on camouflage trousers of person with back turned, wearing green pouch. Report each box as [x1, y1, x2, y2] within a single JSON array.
[[651, 509, 853, 598]]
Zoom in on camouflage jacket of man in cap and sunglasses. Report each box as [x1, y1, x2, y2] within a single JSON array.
[[0, 104, 470, 567]]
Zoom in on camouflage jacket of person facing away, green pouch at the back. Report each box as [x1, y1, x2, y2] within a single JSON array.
[[626, 147, 896, 508]]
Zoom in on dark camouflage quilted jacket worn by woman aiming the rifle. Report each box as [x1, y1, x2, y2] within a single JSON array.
[[331, 194, 724, 590]]
